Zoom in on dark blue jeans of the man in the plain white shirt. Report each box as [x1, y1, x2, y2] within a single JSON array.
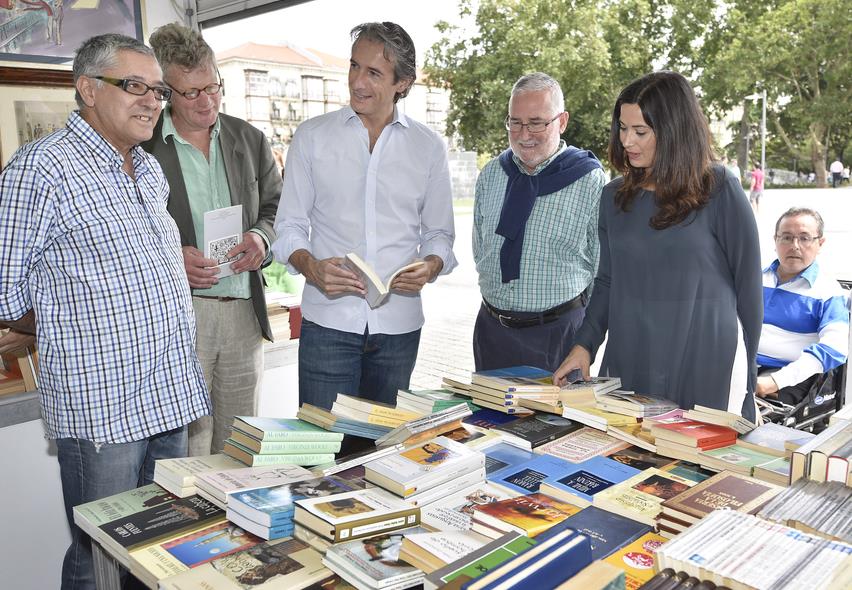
[[299, 318, 420, 409]]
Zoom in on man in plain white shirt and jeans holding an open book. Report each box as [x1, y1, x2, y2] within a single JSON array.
[[272, 22, 457, 408]]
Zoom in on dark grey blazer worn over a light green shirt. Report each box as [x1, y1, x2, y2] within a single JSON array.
[[142, 114, 281, 341]]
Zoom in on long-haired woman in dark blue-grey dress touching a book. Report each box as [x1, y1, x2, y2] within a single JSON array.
[[554, 72, 763, 420]]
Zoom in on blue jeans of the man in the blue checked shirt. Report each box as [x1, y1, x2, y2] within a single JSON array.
[[56, 427, 187, 590]]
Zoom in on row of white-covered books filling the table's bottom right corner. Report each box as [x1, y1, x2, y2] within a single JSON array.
[[654, 510, 852, 590]]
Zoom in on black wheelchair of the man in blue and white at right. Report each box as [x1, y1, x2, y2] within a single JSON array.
[[755, 280, 852, 434]]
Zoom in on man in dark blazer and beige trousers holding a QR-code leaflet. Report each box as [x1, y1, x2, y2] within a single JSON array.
[[142, 23, 281, 456]]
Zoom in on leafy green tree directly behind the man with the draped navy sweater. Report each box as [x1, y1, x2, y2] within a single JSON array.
[[426, 0, 662, 159]]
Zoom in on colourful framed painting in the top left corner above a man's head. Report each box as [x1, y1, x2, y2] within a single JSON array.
[[0, 0, 142, 64]]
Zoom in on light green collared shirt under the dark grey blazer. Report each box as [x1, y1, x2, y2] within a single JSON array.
[[163, 108, 251, 299]]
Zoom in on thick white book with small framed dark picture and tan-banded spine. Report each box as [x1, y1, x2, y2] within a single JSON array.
[[294, 488, 420, 543]]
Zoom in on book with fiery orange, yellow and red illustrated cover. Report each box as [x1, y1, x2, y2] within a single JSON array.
[[473, 494, 580, 537]]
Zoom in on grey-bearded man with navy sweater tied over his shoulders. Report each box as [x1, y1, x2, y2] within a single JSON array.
[[473, 72, 606, 371]]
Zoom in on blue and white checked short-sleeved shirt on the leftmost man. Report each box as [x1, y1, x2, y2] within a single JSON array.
[[0, 112, 210, 443]]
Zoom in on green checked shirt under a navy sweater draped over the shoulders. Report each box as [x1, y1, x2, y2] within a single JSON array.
[[473, 141, 606, 312]]
